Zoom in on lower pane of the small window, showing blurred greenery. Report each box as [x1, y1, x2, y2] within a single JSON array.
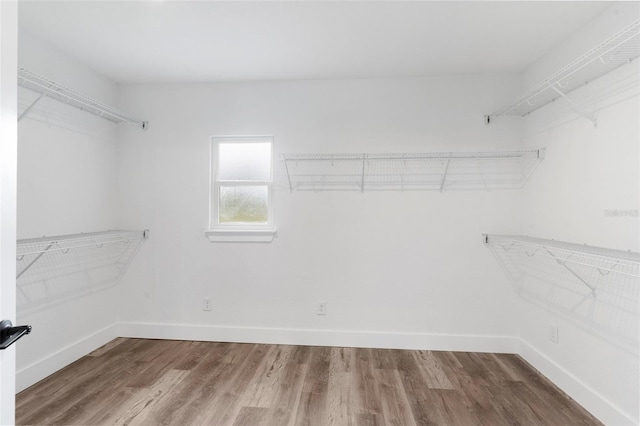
[[218, 185, 269, 223]]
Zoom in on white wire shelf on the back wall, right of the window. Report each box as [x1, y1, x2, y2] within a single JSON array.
[[281, 149, 544, 192]]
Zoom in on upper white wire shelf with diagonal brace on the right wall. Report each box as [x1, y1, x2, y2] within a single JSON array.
[[485, 20, 640, 124]]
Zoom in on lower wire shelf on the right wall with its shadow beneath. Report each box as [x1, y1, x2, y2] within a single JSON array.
[[489, 236, 640, 354]]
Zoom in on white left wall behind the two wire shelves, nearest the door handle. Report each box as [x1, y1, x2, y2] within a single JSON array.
[[17, 32, 123, 390]]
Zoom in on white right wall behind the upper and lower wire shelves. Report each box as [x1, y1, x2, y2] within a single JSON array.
[[517, 3, 640, 424]]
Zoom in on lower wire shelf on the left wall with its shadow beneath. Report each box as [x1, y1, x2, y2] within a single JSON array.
[[16, 231, 146, 314]]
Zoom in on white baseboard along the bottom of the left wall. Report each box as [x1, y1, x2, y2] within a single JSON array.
[[16, 325, 118, 392]]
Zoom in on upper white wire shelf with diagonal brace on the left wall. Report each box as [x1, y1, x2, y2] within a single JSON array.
[[18, 68, 148, 129]]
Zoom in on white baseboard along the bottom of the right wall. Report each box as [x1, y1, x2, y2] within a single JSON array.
[[518, 340, 638, 426]]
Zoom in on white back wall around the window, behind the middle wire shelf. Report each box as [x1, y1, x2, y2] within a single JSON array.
[[118, 75, 520, 351]]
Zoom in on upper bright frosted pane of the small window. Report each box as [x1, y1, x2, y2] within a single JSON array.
[[218, 142, 271, 181]]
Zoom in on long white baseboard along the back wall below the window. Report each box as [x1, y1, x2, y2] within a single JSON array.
[[118, 323, 518, 353]]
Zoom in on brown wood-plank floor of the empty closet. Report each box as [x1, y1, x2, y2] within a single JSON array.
[[16, 338, 600, 426]]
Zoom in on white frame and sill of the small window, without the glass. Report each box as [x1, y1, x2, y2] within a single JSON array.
[[205, 136, 276, 242]]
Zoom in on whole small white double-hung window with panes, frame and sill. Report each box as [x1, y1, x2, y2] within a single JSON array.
[[207, 136, 275, 242]]
